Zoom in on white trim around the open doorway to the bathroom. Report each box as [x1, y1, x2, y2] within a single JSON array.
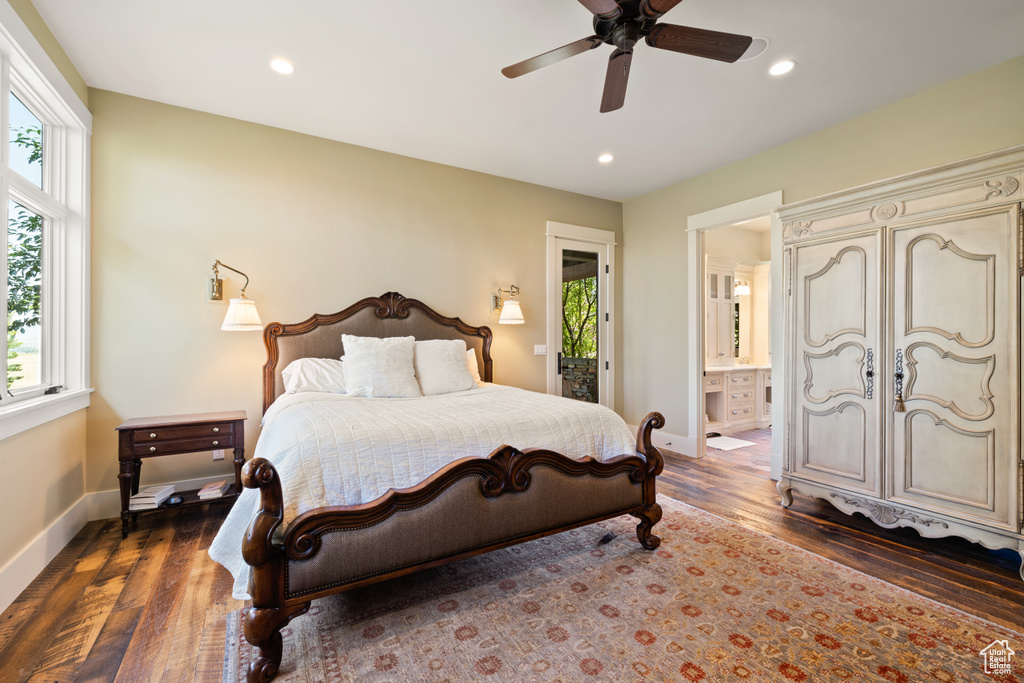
[[686, 189, 787, 479]]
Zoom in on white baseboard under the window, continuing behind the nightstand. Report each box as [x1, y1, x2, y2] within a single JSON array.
[[0, 475, 233, 612]]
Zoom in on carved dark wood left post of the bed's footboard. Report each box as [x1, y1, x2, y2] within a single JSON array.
[[242, 458, 309, 683]]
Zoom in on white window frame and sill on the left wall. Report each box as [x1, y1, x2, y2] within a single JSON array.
[[0, 3, 92, 439]]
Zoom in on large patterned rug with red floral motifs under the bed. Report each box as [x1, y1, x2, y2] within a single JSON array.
[[224, 497, 1024, 683]]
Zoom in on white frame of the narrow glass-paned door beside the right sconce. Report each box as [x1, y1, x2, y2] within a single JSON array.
[[545, 220, 617, 411]]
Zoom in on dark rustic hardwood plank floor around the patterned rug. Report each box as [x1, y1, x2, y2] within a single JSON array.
[[0, 453, 1024, 683]]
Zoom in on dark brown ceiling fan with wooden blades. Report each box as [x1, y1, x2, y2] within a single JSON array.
[[502, 0, 754, 113]]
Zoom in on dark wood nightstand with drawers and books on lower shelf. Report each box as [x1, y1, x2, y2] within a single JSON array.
[[118, 411, 246, 539]]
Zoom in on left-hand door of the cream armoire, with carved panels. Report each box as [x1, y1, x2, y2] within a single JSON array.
[[790, 230, 882, 495]]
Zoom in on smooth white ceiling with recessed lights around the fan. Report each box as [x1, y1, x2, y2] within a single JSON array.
[[34, 0, 1024, 200]]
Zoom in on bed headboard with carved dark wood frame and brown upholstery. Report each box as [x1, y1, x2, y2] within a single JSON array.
[[263, 292, 492, 413]]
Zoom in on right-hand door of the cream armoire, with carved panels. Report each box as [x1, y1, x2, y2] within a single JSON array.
[[886, 206, 1020, 529]]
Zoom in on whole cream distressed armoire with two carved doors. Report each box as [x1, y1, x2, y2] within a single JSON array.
[[777, 145, 1024, 578]]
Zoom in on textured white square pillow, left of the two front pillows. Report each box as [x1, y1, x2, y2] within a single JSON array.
[[341, 335, 420, 398]]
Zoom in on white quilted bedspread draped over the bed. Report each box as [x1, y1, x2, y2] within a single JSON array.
[[210, 384, 635, 600]]
